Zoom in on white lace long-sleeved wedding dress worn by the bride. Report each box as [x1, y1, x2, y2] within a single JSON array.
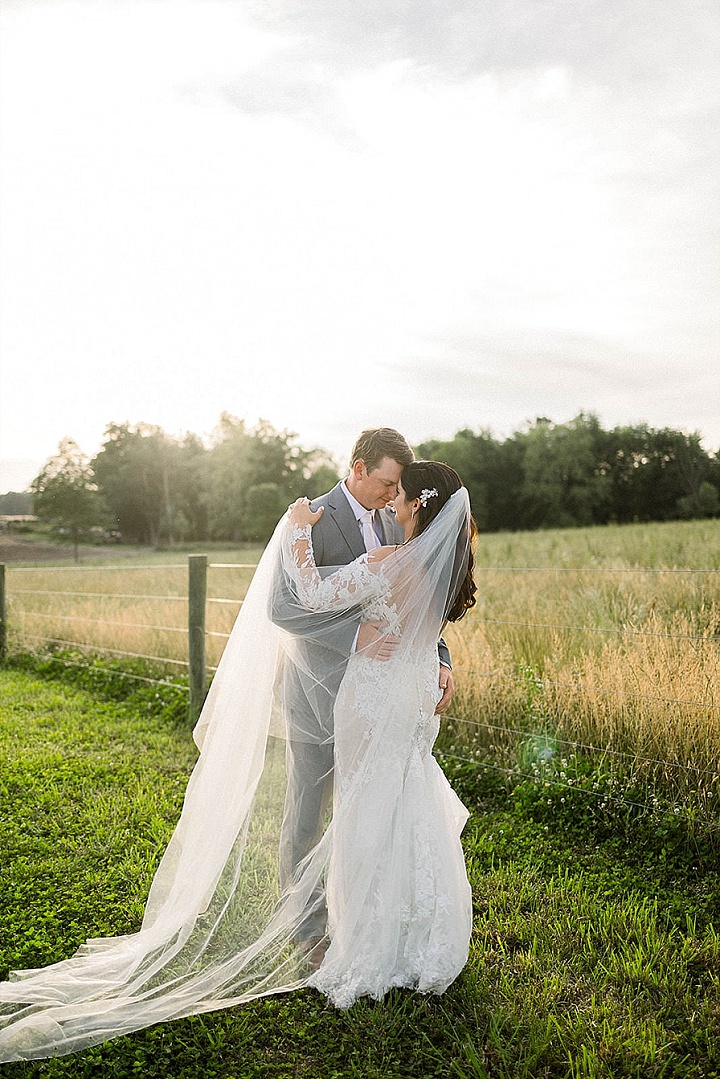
[[294, 530, 472, 1008]]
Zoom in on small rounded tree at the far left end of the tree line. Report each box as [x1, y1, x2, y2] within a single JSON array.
[[30, 438, 103, 562]]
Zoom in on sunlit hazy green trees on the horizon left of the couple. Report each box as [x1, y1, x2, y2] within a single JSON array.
[[30, 413, 338, 547]]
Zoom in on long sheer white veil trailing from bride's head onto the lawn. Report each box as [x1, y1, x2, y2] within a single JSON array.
[[0, 489, 470, 1061]]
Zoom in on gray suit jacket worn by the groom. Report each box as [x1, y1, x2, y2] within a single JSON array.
[[272, 483, 450, 742]]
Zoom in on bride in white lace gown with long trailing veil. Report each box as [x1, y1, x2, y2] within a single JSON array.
[[0, 462, 475, 1061]]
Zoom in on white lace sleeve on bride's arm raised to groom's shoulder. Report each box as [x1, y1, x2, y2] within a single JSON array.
[[286, 524, 379, 611]]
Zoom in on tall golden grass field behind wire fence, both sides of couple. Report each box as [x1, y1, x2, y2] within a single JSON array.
[[8, 520, 720, 816]]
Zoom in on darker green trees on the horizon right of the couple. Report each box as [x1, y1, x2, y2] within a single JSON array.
[[417, 412, 720, 532]]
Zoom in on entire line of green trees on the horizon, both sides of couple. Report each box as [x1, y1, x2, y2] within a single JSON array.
[[11, 413, 720, 546]]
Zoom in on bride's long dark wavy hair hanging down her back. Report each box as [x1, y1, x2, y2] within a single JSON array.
[[400, 461, 477, 622]]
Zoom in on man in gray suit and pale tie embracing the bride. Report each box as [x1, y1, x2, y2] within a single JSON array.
[[273, 427, 453, 948]]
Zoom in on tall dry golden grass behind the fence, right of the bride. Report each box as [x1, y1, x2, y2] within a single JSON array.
[[449, 521, 720, 807]]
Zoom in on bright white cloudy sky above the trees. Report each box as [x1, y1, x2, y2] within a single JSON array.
[[0, 0, 720, 491]]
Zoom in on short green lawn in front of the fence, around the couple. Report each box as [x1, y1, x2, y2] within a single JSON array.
[[0, 669, 720, 1079]]
